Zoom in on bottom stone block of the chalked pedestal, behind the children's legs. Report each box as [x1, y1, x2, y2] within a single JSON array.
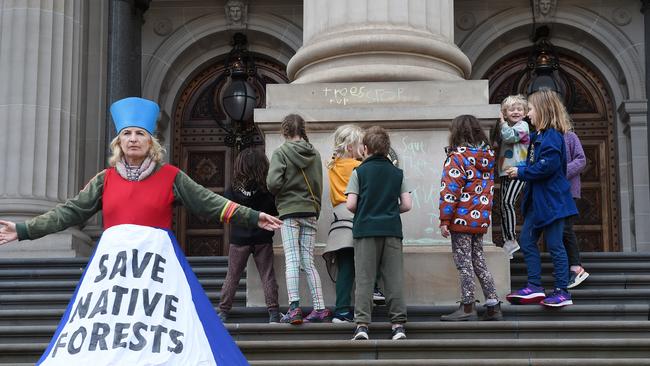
[[246, 245, 510, 306]]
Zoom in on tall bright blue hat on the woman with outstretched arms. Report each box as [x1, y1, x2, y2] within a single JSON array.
[[111, 97, 160, 135]]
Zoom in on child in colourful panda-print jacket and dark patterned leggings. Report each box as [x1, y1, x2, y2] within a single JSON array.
[[440, 115, 503, 321]]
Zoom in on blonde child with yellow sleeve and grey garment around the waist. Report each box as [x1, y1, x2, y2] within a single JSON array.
[[323, 124, 363, 323]]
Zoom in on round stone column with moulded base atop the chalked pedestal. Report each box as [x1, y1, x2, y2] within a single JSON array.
[[287, 0, 470, 83]]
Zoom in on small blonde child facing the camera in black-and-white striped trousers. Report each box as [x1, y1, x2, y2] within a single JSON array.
[[497, 95, 530, 259]]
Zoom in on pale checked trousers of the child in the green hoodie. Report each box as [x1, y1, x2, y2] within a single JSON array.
[[280, 217, 325, 310]]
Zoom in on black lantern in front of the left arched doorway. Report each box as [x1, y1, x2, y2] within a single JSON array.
[[210, 33, 258, 150]]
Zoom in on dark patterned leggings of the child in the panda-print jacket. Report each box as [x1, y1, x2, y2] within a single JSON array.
[[451, 231, 497, 304]]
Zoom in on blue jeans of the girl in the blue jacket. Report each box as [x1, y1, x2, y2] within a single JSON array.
[[519, 214, 569, 289]]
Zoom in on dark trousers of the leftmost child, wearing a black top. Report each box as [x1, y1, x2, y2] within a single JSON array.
[[219, 244, 278, 312]]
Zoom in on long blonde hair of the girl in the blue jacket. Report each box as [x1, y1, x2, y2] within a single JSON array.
[[528, 88, 571, 134]]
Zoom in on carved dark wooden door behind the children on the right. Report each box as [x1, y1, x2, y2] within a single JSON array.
[[484, 52, 620, 252]]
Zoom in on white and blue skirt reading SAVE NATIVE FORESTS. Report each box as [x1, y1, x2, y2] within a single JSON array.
[[38, 225, 248, 366]]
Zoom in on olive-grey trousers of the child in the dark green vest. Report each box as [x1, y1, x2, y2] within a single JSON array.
[[354, 236, 406, 324]]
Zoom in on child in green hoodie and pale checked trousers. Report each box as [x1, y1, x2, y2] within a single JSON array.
[[266, 114, 332, 324]]
